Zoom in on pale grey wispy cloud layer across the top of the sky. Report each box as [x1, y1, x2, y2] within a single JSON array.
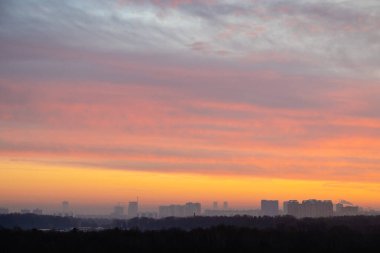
[[0, 1, 380, 77]]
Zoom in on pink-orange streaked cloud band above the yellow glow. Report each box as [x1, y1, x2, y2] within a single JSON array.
[[0, 77, 380, 180]]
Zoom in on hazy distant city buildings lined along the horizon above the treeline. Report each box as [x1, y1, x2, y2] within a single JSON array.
[[0, 199, 380, 219]]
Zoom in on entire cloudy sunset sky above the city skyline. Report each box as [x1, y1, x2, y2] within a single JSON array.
[[0, 0, 380, 212]]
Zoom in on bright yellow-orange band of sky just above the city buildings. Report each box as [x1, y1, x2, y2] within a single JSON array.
[[0, 160, 380, 211]]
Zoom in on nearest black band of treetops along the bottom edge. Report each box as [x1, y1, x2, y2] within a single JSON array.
[[0, 226, 380, 253]]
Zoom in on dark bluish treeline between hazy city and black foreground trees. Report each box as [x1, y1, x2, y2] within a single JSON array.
[[0, 214, 380, 232]]
